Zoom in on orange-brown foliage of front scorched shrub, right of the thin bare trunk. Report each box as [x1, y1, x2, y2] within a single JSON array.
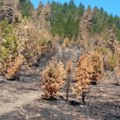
[[73, 55, 94, 98]]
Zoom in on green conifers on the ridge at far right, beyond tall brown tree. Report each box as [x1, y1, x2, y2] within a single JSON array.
[[91, 7, 120, 40]]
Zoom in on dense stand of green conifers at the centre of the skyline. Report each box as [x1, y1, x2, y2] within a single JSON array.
[[51, 0, 84, 39]]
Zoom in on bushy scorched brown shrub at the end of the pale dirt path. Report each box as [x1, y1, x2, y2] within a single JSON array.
[[42, 60, 66, 99]]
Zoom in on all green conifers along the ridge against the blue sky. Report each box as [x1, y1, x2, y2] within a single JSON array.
[[20, 0, 120, 40]]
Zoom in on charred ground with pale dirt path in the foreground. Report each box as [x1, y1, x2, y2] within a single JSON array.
[[0, 77, 120, 120]]
